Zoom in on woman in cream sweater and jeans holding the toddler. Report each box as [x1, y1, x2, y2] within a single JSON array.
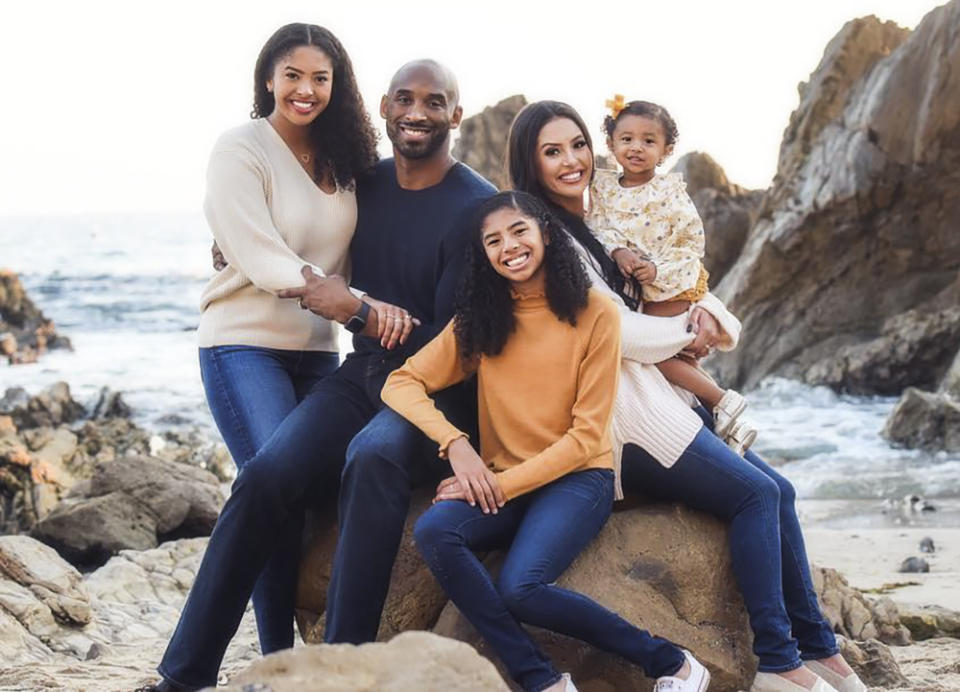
[[508, 101, 866, 692]]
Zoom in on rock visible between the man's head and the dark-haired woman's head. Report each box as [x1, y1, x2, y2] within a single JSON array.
[[453, 94, 527, 190]]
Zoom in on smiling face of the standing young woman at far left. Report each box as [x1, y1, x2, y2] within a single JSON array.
[[267, 46, 333, 127]]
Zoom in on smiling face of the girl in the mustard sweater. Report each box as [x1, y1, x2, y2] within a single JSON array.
[[480, 207, 549, 292]]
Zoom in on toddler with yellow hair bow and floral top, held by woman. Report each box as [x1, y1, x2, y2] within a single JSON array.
[[586, 95, 757, 454]]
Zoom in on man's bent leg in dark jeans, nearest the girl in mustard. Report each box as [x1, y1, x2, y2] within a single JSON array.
[[324, 398, 477, 644]]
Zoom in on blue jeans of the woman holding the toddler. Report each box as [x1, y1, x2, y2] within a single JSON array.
[[621, 409, 839, 673]]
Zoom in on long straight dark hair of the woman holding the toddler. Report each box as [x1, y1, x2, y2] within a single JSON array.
[[507, 101, 641, 310]]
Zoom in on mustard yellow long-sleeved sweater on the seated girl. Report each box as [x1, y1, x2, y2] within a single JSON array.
[[382, 289, 620, 499]]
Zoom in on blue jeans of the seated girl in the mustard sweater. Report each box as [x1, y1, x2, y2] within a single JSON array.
[[414, 469, 684, 690]]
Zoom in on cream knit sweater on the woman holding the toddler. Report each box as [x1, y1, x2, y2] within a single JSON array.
[[571, 237, 740, 499]]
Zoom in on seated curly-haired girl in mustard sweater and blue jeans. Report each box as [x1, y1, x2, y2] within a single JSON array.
[[383, 192, 710, 692]]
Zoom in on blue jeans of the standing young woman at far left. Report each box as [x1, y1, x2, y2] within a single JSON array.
[[200, 346, 340, 654]]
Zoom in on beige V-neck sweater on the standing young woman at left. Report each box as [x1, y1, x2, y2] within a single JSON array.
[[197, 119, 357, 352]]
